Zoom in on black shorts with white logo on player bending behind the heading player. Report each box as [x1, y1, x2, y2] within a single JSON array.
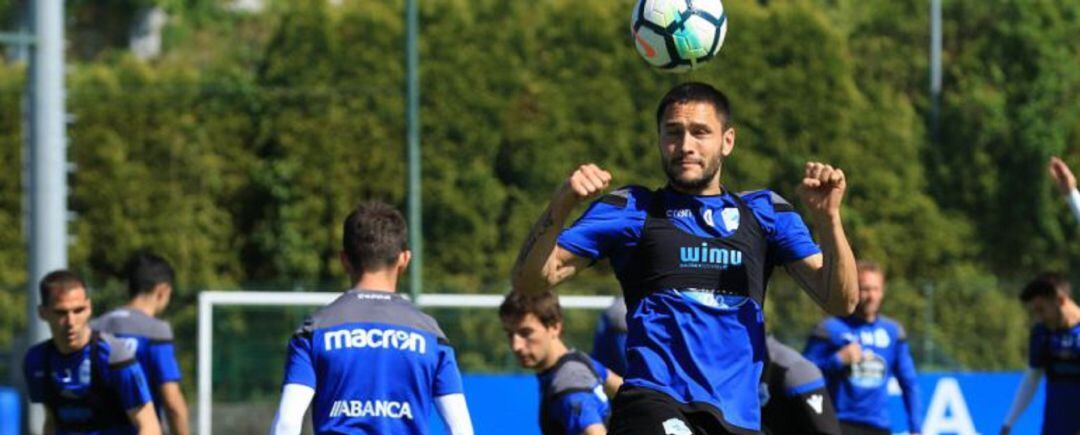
[[761, 386, 840, 435]]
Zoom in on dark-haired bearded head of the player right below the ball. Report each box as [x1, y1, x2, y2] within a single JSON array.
[[657, 82, 735, 192]]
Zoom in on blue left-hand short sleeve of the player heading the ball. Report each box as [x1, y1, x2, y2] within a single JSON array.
[[556, 188, 645, 260]]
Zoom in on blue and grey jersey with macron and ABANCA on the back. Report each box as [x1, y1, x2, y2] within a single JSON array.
[[284, 290, 462, 434]]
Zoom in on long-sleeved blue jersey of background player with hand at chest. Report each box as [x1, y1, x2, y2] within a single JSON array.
[[802, 315, 922, 432]]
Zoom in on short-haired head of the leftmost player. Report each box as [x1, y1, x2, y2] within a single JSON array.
[[38, 270, 93, 351]]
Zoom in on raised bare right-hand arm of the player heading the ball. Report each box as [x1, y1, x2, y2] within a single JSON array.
[[787, 162, 859, 315]]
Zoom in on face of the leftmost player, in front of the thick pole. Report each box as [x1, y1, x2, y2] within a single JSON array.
[[38, 287, 92, 350]]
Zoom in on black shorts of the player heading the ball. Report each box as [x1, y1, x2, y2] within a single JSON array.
[[608, 385, 757, 435]]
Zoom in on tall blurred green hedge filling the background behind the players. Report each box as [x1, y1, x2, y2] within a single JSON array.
[[0, 0, 1080, 433]]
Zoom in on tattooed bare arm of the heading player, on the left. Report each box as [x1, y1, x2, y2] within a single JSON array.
[[511, 163, 611, 293]]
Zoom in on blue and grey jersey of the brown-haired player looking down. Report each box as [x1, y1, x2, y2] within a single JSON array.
[[537, 351, 611, 435]]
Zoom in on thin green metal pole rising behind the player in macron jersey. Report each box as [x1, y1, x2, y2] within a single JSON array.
[[405, 0, 423, 301]]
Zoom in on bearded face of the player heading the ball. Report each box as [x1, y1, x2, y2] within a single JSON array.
[[660, 101, 735, 193]]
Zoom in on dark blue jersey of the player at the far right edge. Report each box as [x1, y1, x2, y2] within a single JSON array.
[[1028, 324, 1080, 434]]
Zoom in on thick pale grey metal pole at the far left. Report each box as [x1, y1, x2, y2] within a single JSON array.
[[27, 0, 68, 433]]
